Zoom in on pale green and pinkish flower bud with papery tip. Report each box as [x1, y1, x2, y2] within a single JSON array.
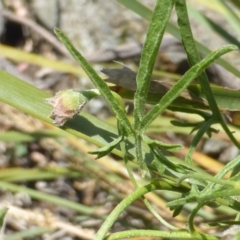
[[45, 89, 88, 126]]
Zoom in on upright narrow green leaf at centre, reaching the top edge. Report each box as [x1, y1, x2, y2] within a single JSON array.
[[134, 0, 175, 125]]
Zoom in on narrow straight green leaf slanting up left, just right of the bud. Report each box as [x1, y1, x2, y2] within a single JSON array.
[[55, 29, 133, 133]]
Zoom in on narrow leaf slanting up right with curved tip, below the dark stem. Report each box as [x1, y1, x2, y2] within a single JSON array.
[[142, 45, 237, 129]]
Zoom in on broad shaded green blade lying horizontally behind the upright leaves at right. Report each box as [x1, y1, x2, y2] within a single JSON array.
[[111, 80, 240, 126]]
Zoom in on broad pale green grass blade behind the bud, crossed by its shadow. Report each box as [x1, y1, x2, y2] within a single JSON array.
[[0, 70, 121, 152]]
